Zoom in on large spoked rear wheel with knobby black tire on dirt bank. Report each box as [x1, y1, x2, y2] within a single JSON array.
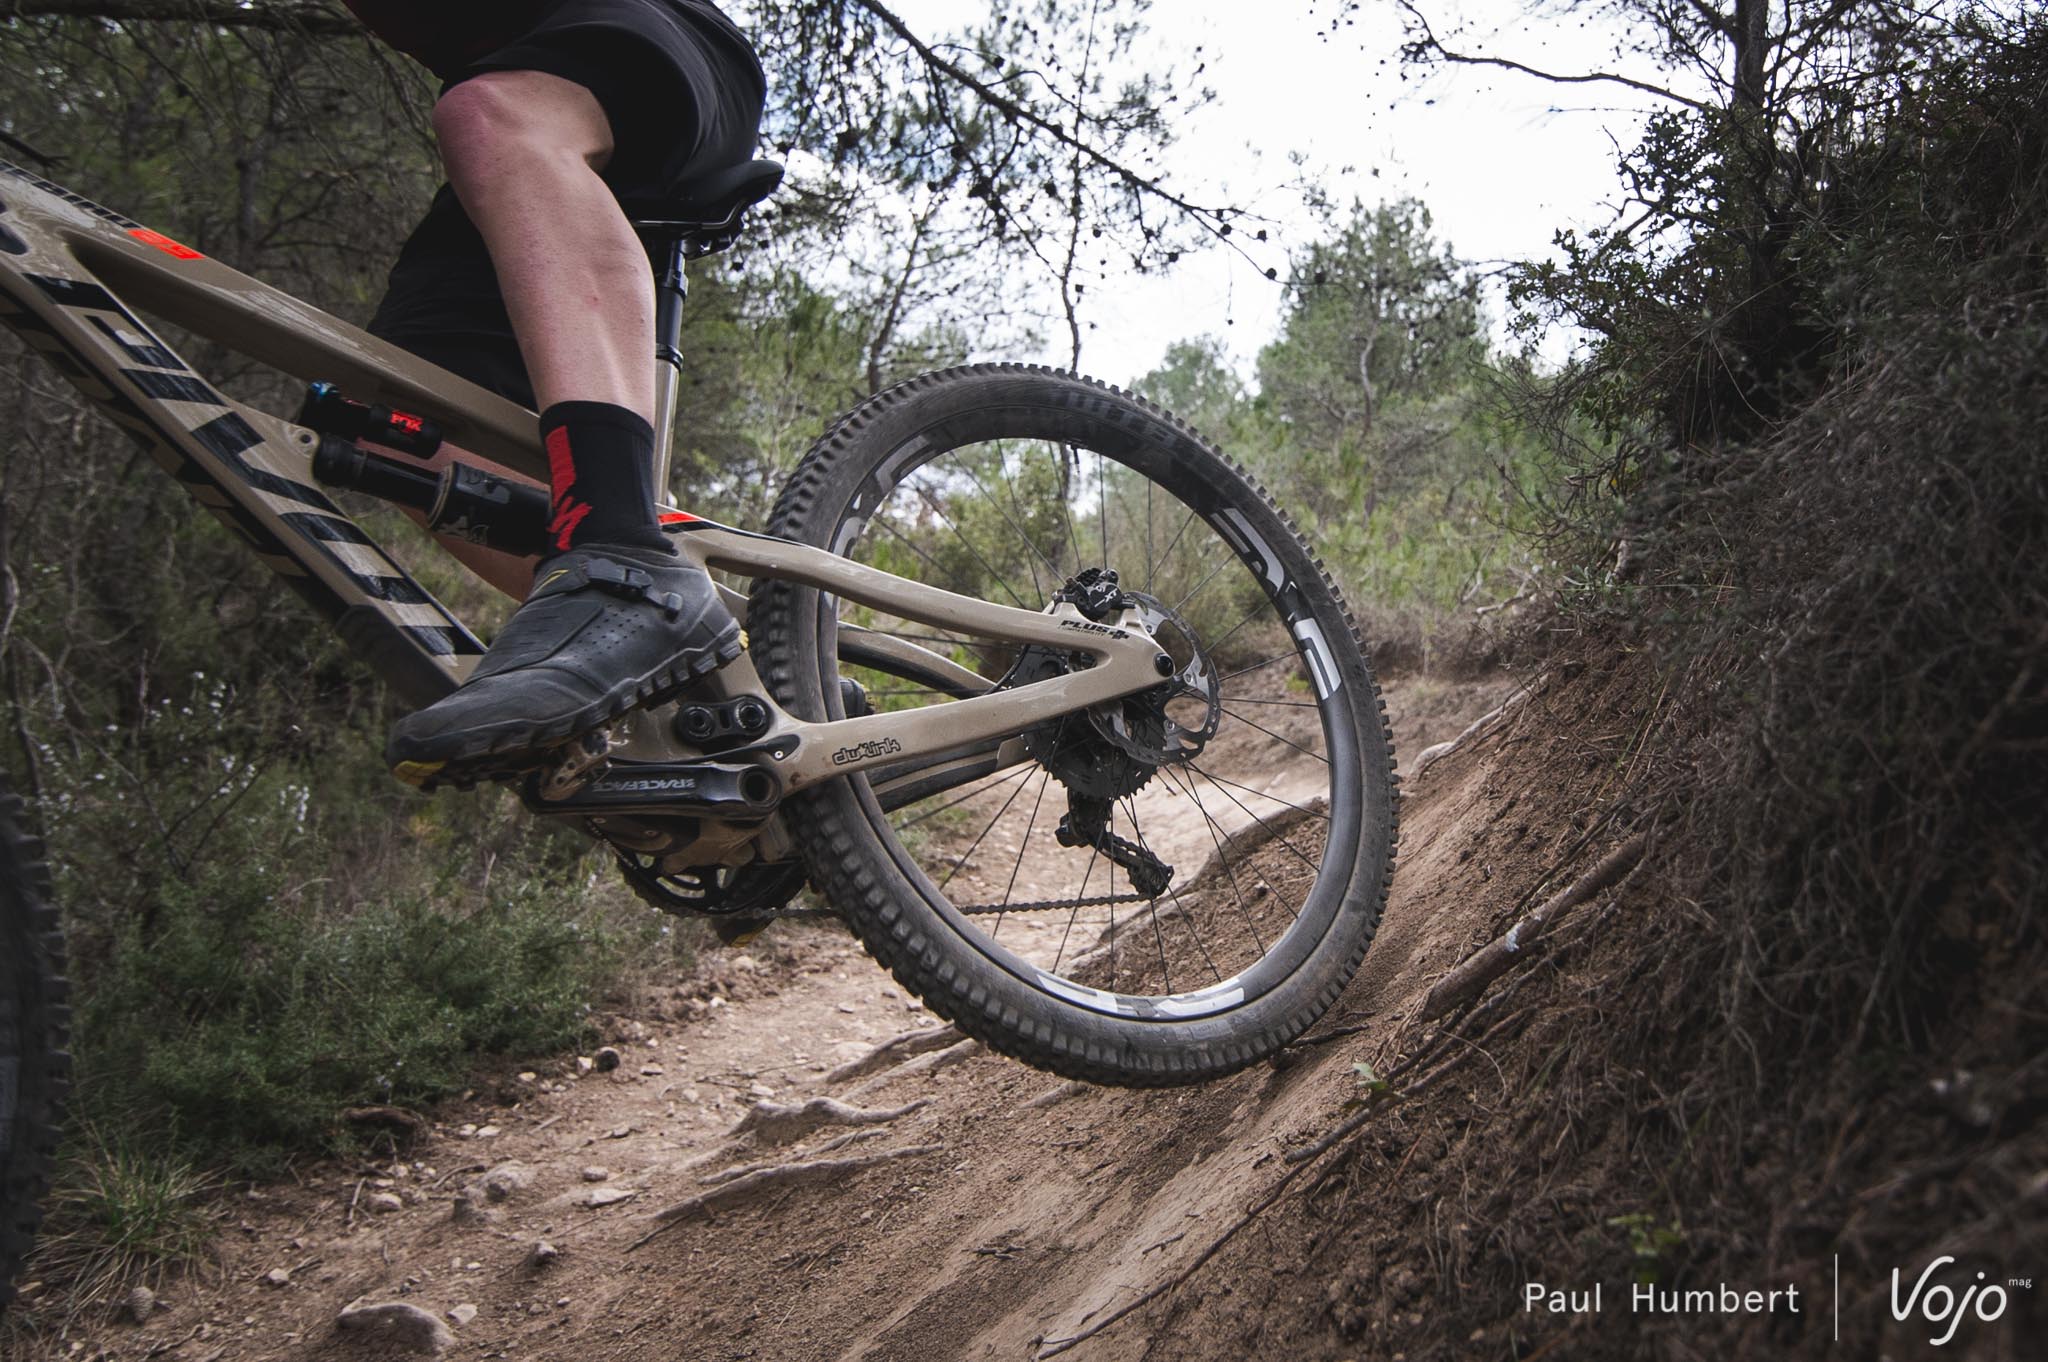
[[748, 367, 1395, 1086]]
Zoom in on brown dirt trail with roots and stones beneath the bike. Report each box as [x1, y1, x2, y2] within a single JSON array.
[[12, 680, 1507, 1362]]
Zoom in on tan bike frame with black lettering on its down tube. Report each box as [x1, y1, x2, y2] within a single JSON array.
[[0, 162, 1159, 813]]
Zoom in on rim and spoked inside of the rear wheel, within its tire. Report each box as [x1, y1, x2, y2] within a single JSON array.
[[817, 387, 1362, 1022]]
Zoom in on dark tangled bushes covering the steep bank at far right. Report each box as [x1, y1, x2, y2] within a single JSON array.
[[1392, 4, 2048, 1356]]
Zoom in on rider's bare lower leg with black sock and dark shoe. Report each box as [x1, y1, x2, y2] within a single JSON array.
[[387, 70, 739, 782]]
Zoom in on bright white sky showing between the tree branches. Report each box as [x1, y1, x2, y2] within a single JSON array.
[[895, 0, 1649, 383]]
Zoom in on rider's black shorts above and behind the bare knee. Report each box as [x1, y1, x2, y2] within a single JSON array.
[[369, 0, 766, 408]]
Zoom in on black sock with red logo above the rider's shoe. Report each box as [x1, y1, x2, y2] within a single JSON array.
[[541, 401, 670, 553]]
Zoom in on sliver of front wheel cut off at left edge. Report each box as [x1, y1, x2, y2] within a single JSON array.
[[0, 786, 68, 1309]]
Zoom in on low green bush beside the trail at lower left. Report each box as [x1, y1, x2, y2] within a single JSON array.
[[80, 798, 623, 1169]]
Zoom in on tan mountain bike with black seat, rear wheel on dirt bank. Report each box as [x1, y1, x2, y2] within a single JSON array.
[[0, 151, 1395, 1310]]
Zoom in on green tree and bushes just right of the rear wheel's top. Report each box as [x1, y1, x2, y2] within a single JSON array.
[[1135, 201, 1540, 662]]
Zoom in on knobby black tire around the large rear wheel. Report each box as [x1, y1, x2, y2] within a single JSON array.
[[750, 365, 1397, 1088]]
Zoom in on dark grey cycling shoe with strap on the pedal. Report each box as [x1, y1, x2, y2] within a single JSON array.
[[385, 545, 741, 786]]
